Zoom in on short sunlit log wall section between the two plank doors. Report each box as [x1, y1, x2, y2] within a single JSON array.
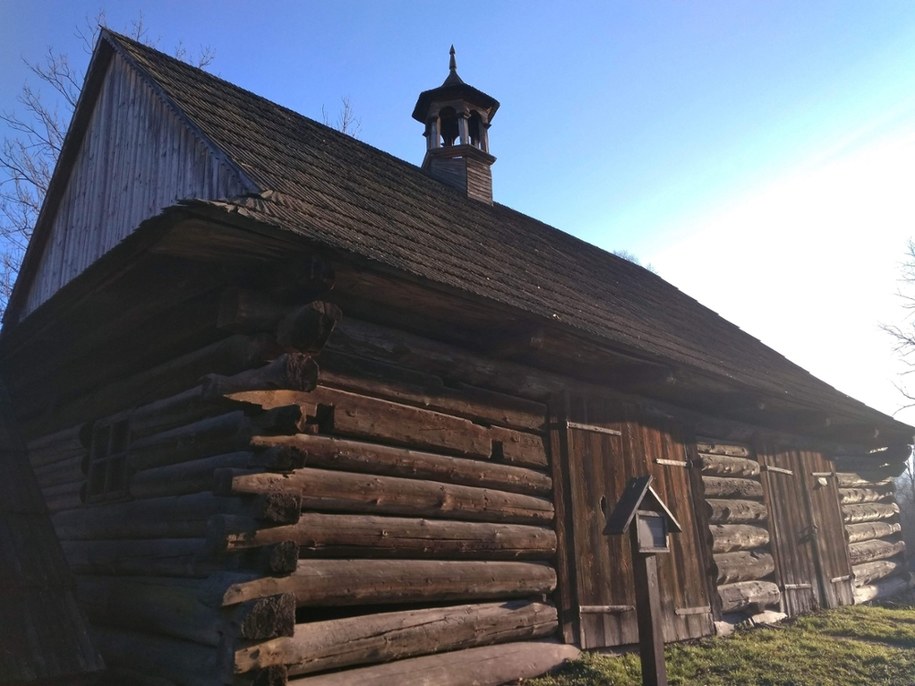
[[696, 441, 780, 613]]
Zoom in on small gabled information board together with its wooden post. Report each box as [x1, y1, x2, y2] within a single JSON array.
[[604, 475, 682, 686]]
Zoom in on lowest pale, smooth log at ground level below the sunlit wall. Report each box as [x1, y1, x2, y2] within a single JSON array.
[[289, 641, 579, 686]]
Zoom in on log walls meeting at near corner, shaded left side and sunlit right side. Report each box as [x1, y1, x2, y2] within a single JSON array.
[[21, 284, 558, 683]]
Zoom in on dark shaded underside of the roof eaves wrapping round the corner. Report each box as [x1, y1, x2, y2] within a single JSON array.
[[4, 205, 910, 453]]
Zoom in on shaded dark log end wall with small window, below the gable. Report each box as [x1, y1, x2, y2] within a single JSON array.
[[21, 286, 350, 684]]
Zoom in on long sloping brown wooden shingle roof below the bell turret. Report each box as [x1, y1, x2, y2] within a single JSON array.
[[17, 31, 913, 452]]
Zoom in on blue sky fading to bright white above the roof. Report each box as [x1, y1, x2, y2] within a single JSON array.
[[0, 0, 915, 422]]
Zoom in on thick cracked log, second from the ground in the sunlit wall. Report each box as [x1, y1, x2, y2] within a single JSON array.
[[235, 600, 558, 676]]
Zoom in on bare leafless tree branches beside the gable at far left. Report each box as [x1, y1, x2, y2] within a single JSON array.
[[0, 13, 213, 311]]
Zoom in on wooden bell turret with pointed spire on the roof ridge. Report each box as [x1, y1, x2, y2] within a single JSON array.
[[413, 45, 499, 205]]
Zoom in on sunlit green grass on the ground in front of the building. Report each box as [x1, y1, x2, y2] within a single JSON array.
[[524, 604, 915, 686]]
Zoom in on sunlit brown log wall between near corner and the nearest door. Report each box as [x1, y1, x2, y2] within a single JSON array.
[[223, 312, 558, 680]]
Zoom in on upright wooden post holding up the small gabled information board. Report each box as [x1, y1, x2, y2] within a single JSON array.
[[629, 527, 667, 686]]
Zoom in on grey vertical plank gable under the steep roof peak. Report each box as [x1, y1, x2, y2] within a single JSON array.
[[23, 55, 254, 315]]
